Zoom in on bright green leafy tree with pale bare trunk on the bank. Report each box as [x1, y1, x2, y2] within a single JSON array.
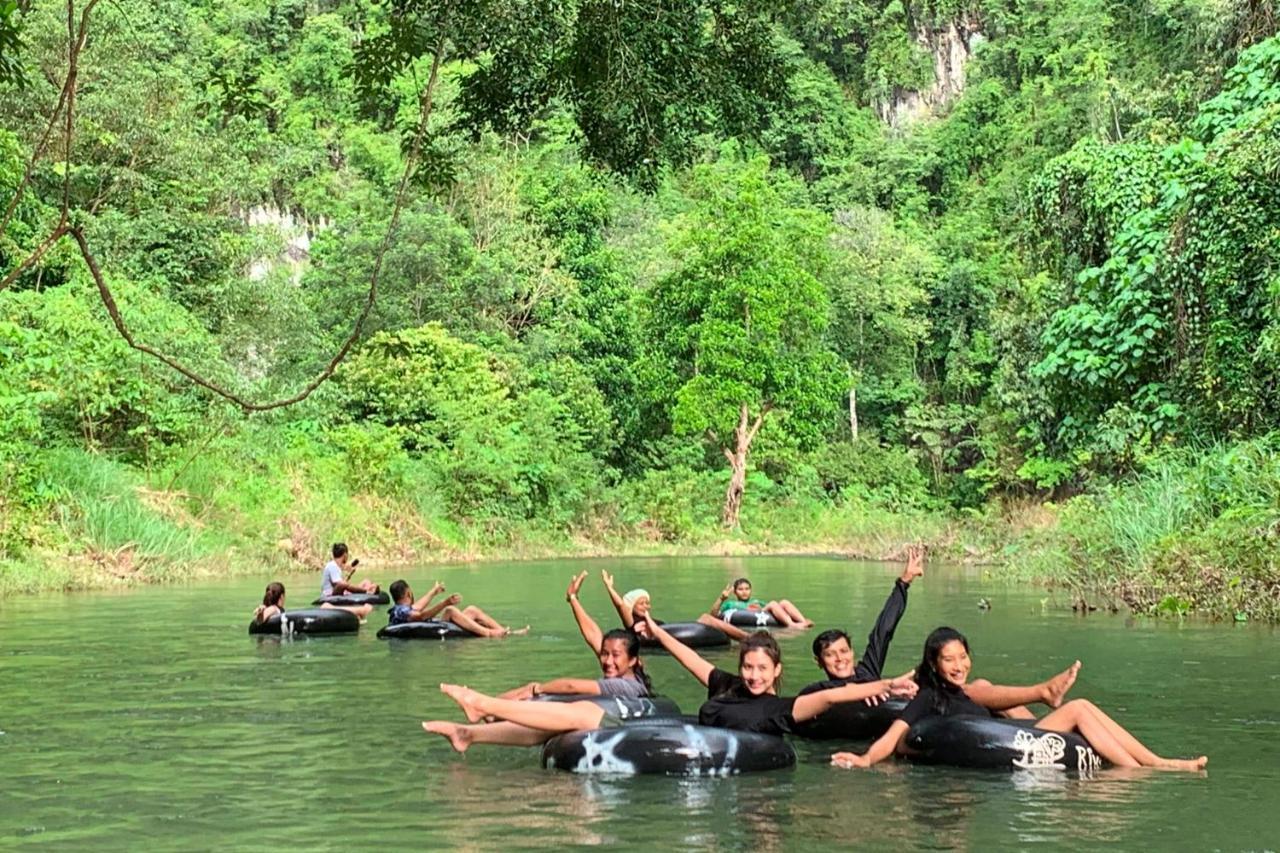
[[641, 156, 844, 528]]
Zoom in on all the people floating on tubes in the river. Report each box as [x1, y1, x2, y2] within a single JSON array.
[[255, 546, 1208, 771]]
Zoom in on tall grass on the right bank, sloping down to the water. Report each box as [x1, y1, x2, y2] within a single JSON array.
[[1012, 437, 1280, 620]]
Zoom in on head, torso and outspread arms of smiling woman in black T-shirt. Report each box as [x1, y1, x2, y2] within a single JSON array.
[[646, 613, 915, 734]]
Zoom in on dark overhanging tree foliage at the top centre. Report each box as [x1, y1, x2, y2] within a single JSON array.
[[357, 0, 791, 182]]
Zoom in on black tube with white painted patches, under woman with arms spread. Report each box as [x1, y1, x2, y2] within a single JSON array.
[[543, 721, 796, 776]]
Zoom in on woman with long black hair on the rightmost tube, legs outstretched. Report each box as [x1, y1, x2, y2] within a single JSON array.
[[831, 628, 1208, 770]]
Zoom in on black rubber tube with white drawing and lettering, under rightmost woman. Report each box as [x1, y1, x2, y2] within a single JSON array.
[[904, 715, 1102, 774]]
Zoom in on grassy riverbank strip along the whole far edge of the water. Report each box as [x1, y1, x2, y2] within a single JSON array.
[[0, 442, 1280, 621]]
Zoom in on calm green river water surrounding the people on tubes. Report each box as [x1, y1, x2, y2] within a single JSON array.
[[0, 557, 1280, 850]]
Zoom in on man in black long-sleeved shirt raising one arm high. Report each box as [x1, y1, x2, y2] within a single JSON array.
[[796, 546, 924, 738]]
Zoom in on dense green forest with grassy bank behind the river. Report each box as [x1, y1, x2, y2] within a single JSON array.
[[0, 0, 1280, 619]]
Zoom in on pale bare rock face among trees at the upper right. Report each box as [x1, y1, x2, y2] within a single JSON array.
[[876, 13, 983, 127]]
